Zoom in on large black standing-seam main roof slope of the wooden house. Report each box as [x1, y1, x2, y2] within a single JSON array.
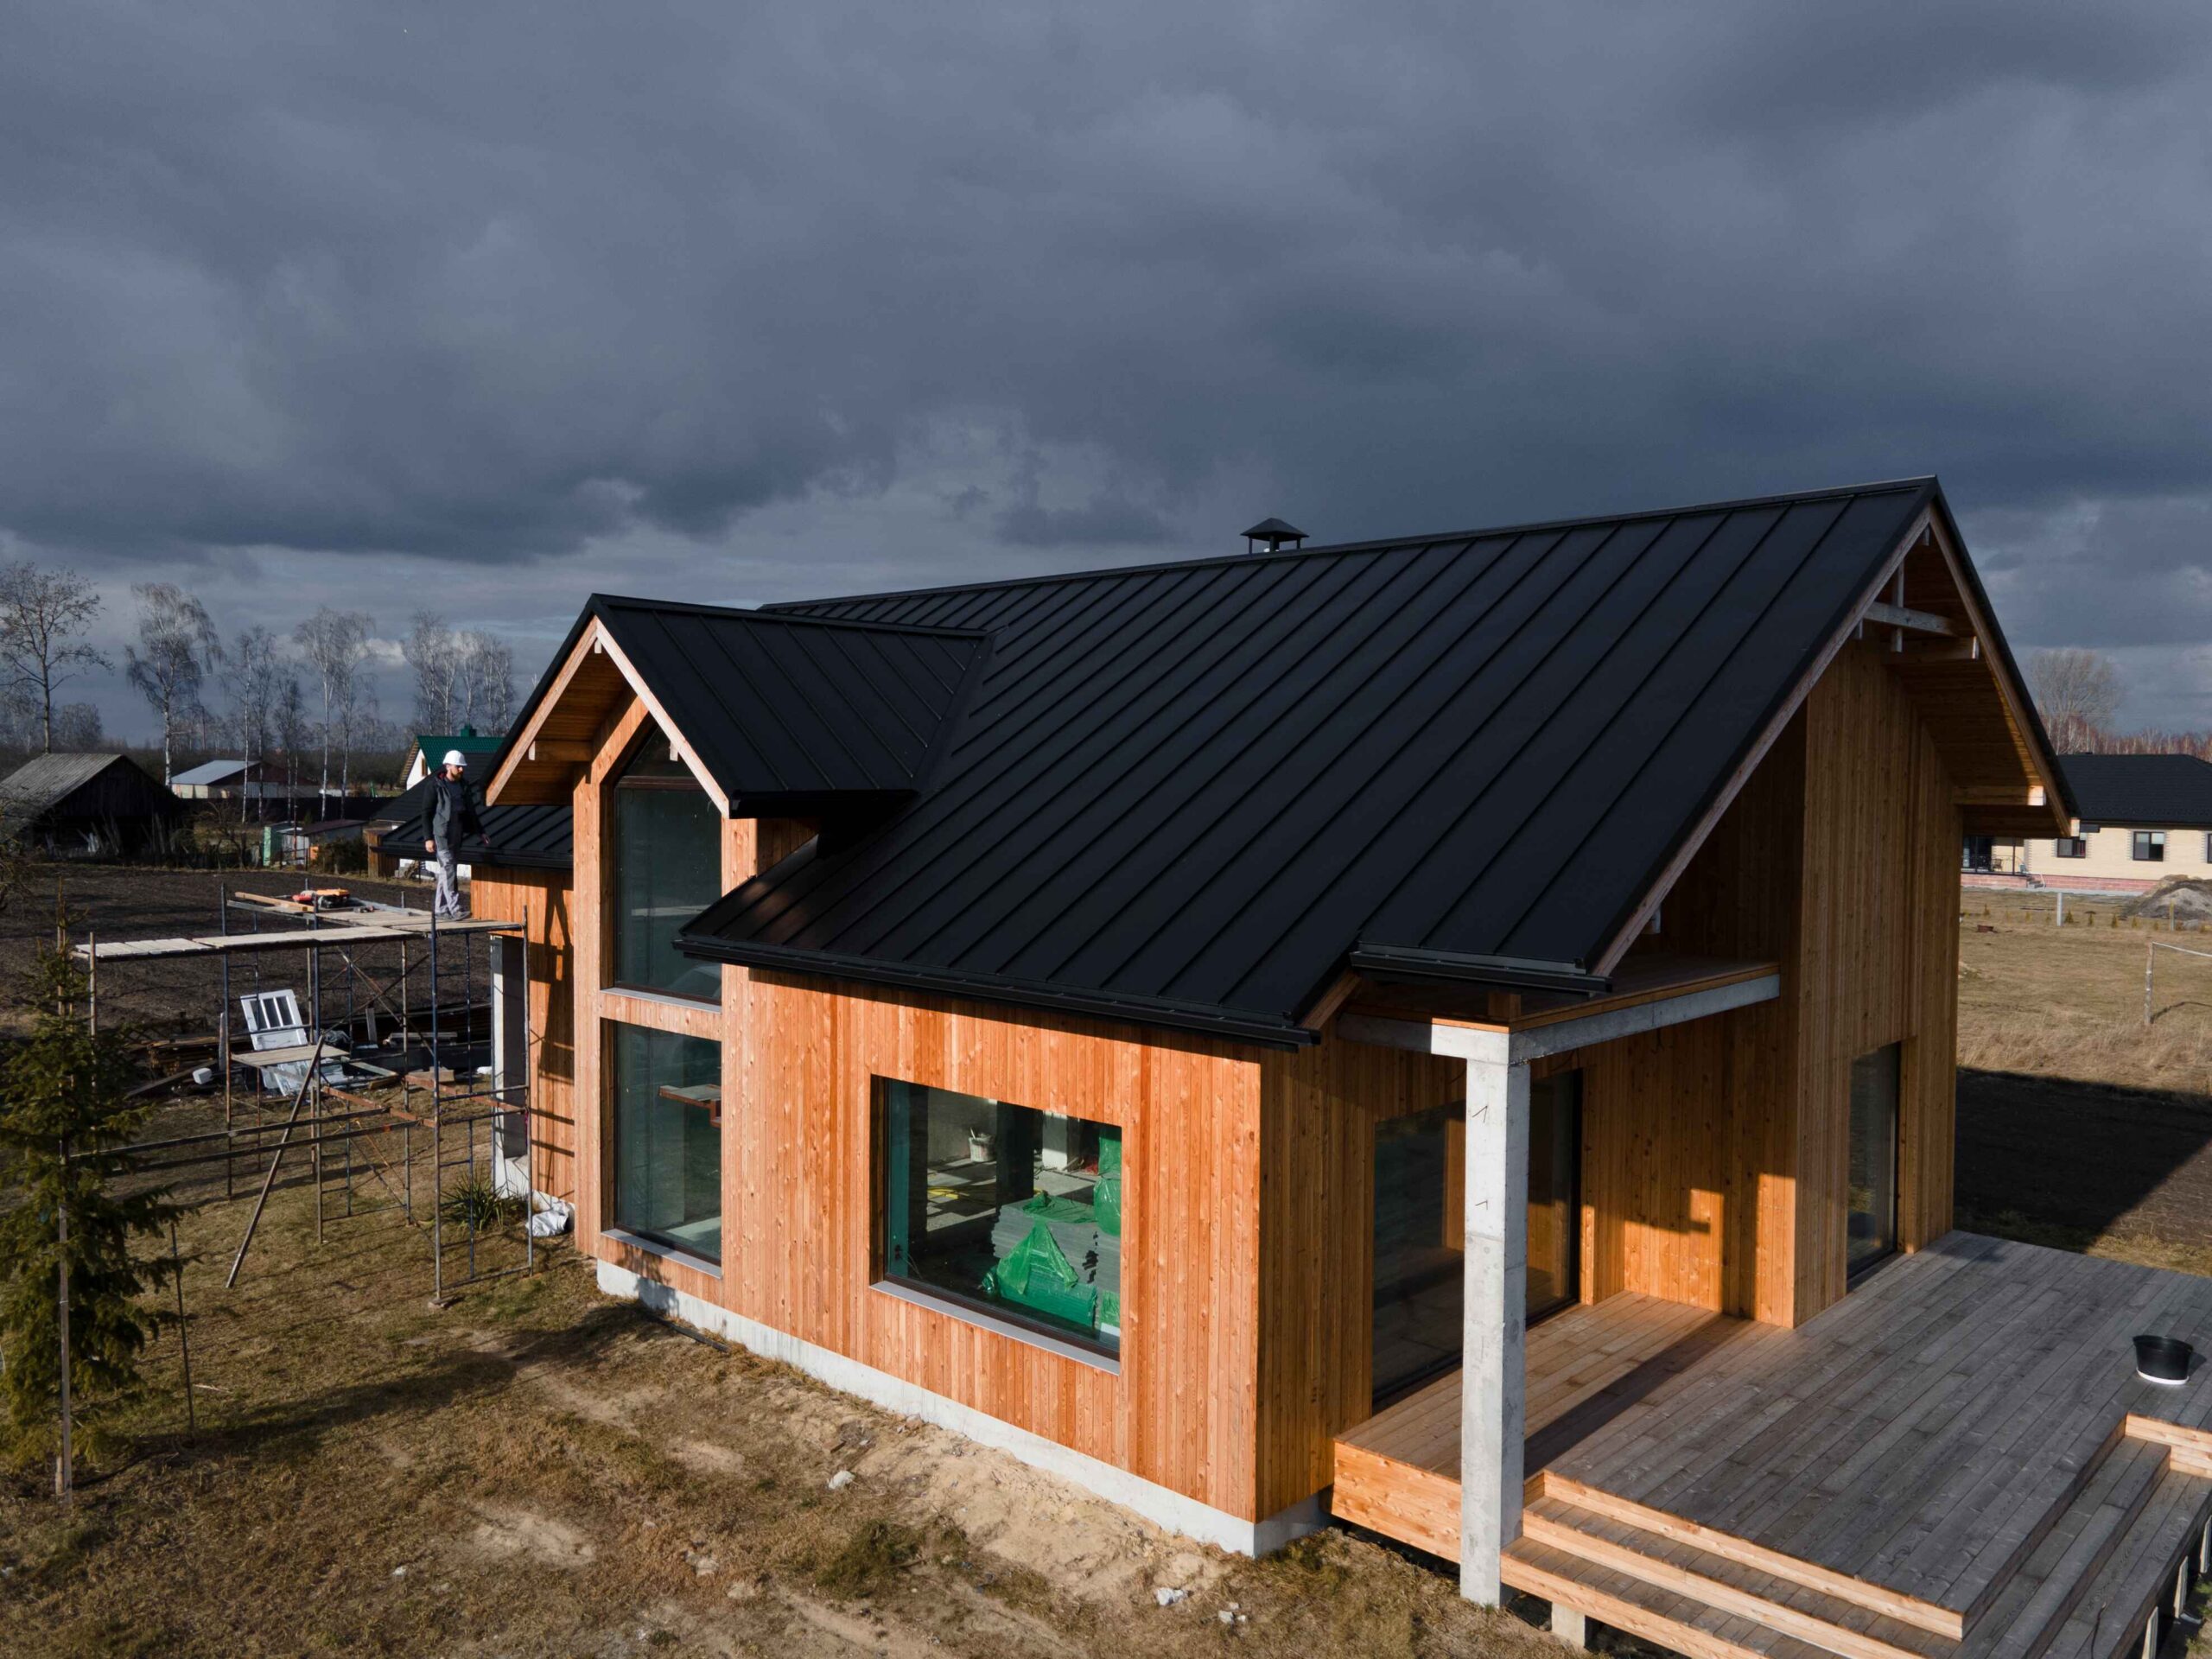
[[677, 478, 1940, 1042]]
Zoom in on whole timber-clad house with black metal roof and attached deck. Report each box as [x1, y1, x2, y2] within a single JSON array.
[[475, 480, 2212, 1659]]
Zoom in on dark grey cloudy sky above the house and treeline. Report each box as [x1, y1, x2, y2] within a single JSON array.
[[0, 0, 2212, 730]]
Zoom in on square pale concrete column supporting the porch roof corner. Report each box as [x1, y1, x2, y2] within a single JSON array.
[[1460, 1031, 1529, 1606]]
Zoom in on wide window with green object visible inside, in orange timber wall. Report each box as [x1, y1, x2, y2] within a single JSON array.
[[878, 1079, 1126, 1354]]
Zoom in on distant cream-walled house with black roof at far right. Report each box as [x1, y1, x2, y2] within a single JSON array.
[[1962, 754, 2212, 893]]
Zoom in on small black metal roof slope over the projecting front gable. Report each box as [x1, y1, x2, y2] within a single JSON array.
[[593, 595, 988, 814]]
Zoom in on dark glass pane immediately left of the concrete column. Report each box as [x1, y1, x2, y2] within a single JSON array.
[[1374, 1103, 1466, 1400]]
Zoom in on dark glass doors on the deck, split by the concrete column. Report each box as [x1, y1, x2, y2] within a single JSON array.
[[1371, 1071, 1581, 1407]]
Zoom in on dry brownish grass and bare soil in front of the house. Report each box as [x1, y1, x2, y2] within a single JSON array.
[[0, 1141, 1557, 1659]]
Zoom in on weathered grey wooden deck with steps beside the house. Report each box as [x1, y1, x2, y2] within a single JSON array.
[[1336, 1234, 2212, 1659]]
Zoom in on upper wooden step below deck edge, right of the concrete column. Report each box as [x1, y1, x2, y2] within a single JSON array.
[[1522, 1496, 1958, 1659]]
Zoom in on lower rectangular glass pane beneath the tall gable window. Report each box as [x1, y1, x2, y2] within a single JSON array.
[[613, 1027, 721, 1261]]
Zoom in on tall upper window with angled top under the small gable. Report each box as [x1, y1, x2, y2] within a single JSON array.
[[613, 730, 721, 1002]]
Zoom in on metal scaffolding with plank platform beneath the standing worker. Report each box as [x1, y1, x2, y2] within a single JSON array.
[[71, 885, 542, 1305]]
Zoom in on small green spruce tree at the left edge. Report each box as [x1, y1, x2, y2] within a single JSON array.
[[0, 929, 179, 1466]]
